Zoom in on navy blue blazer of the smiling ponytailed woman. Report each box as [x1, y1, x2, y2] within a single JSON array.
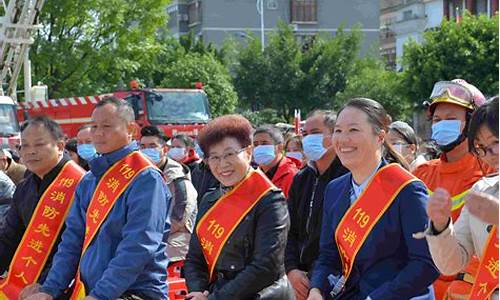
[[311, 162, 439, 300]]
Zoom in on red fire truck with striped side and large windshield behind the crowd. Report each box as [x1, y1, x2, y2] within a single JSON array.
[[17, 88, 210, 137]]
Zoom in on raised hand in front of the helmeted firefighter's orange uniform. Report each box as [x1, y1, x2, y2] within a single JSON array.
[[427, 188, 452, 232]]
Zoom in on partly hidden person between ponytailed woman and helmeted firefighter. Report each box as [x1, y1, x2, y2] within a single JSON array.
[[387, 121, 427, 170]]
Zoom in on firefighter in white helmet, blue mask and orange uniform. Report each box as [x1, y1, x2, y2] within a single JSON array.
[[413, 79, 493, 300]]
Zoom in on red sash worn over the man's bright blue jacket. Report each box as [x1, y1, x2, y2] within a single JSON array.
[[71, 151, 156, 300]]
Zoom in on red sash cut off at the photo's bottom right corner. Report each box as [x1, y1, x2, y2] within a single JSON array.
[[469, 226, 498, 300]]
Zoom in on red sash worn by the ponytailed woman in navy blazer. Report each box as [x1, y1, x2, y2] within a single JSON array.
[[335, 164, 418, 282]]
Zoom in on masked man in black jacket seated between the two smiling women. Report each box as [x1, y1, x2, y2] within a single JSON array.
[[285, 111, 347, 300]]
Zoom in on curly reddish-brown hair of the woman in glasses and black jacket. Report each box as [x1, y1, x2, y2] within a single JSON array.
[[198, 114, 253, 158]]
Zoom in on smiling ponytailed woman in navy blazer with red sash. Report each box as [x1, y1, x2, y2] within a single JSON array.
[[309, 98, 439, 300]]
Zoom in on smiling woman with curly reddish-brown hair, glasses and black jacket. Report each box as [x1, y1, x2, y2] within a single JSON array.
[[185, 115, 293, 299]]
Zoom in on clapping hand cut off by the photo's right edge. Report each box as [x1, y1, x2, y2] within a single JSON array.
[[465, 191, 498, 226]]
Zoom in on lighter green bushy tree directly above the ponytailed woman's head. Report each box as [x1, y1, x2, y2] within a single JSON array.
[[333, 57, 412, 120]]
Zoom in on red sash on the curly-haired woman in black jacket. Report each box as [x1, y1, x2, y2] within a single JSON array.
[[196, 170, 274, 281]]
